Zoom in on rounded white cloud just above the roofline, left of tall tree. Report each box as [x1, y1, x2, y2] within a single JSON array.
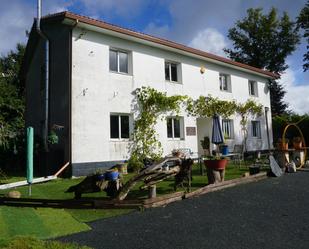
[[189, 28, 227, 56]]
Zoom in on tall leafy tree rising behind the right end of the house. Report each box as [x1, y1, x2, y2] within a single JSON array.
[[224, 8, 299, 115]]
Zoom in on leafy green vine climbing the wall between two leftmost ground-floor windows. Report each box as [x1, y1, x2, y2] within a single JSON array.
[[131, 87, 187, 162]]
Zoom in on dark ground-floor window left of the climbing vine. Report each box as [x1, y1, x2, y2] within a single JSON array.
[[110, 114, 130, 139]]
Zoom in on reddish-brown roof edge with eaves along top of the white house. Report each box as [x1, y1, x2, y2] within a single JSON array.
[[42, 11, 280, 78]]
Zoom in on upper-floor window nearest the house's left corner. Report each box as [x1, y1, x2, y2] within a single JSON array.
[[109, 49, 129, 74]]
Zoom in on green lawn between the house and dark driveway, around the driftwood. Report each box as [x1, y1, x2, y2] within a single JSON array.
[[0, 161, 254, 247]]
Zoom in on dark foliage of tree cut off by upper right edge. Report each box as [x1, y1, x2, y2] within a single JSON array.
[[297, 0, 309, 72]]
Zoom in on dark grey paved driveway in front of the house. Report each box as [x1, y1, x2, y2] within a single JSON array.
[[61, 172, 309, 249]]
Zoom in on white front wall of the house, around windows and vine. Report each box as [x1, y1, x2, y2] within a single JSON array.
[[72, 28, 271, 163]]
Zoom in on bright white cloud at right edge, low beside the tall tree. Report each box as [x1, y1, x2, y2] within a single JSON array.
[[280, 69, 309, 114]]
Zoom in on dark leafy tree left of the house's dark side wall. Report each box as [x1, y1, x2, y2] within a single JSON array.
[[0, 44, 25, 151]]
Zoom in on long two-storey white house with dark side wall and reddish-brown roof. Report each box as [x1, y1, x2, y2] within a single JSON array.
[[23, 12, 277, 176]]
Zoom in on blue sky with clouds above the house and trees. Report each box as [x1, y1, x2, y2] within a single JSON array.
[[0, 0, 309, 114]]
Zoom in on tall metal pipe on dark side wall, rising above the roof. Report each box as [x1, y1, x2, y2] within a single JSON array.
[[36, 0, 49, 151]]
